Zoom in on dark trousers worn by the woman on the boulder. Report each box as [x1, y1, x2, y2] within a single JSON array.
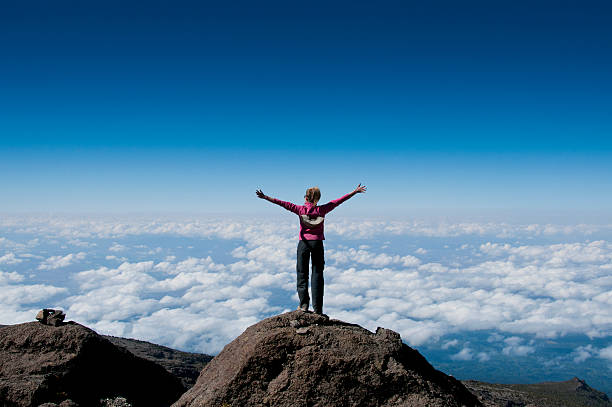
[[297, 240, 325, 314]]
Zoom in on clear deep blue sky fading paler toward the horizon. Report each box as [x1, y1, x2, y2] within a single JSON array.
[[0, 1, 612, 210]]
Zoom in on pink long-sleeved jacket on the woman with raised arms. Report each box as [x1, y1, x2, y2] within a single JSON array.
[[269, 193, 354, 240]]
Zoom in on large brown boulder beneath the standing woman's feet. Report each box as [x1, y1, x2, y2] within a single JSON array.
[[174, 311, 481, 407]]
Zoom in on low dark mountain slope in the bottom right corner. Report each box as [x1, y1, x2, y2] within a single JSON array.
[[462, 377, 612, 407]]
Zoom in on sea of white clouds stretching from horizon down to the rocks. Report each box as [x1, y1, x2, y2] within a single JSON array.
[[0, 215, 612, 394]]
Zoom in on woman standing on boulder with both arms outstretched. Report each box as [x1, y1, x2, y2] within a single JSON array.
[[255, 184, 366, 314]]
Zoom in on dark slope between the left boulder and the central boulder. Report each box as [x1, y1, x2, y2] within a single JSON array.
[[103, 335, 213, 389]]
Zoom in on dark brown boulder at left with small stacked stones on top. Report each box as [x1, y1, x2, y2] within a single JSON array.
[[0, 322, 184, 407]]
